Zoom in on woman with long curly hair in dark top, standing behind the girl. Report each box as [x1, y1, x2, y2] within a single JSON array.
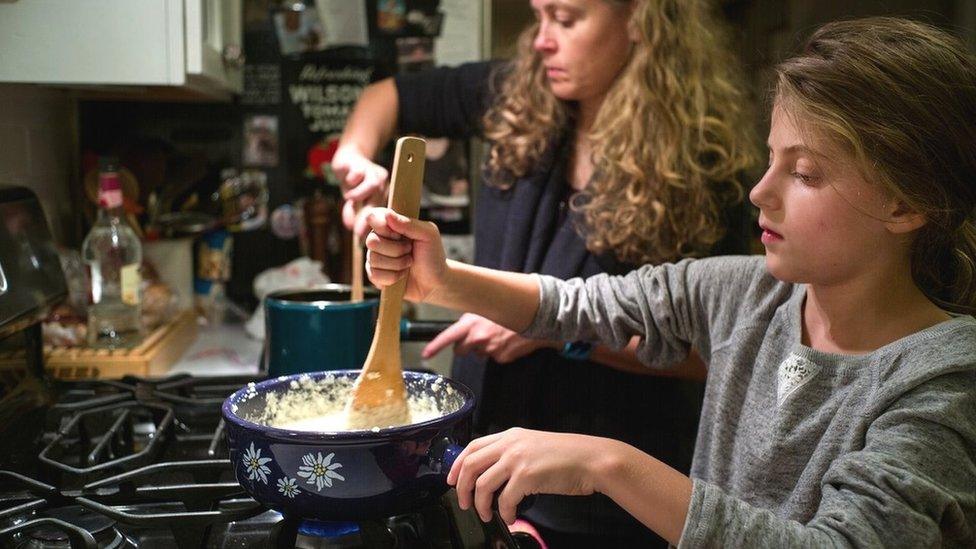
[[333, 0, 753, 546]]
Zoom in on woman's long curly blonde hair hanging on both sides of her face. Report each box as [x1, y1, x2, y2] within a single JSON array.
[[484, 0, 757, 264]]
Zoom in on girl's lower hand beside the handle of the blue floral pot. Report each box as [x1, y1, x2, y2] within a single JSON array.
[[447, 427, 626, 524]]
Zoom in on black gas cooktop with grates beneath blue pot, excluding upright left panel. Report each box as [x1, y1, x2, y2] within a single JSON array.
[[0, 375, 525, 548]]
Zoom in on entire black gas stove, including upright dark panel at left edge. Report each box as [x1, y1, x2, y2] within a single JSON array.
[[0, 187, 536, 549]]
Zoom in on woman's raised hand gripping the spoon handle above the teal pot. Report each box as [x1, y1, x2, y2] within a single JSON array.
[[332, 146, 390, 236]]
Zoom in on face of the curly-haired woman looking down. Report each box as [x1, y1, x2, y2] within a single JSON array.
[[531, 0, 632, 101]]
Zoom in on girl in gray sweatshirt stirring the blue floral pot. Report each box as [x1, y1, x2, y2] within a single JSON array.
[[368, 18, 976, 547]]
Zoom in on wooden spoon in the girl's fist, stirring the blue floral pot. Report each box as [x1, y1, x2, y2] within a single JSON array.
[[346, 137, 426, 429]]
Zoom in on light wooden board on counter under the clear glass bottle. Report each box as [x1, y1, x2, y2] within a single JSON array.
[[0, 310, 197, 379]]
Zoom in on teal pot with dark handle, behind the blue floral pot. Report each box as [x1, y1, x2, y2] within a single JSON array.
[[264, 284, 451, 377]]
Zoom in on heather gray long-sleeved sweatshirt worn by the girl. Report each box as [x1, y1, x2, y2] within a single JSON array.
[[526, 256, 976, 548]]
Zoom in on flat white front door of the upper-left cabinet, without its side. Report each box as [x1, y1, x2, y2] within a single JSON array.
[[0, 0, 186, 85]]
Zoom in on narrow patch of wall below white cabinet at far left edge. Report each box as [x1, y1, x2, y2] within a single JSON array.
[[0, 85, 78, 244]]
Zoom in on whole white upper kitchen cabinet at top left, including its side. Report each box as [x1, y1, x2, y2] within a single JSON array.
[[0, 0, 243, 97]]
